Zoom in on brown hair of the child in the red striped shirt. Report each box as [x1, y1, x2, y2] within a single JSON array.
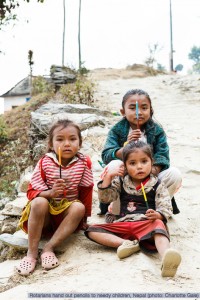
[[47, 119, 82, 152]]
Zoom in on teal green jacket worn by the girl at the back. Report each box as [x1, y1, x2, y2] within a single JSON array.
[[102, 118, 170, 171]]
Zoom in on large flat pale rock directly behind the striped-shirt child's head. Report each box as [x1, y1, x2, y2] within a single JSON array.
[[29, 102, 113, 162]]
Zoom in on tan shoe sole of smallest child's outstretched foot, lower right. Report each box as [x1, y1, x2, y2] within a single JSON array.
[[161, 249, 181, 277]]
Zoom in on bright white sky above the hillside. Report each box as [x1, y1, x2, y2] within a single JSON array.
[[0, 0, 200, 113]]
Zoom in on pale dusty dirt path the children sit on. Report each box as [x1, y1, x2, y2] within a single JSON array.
[[0, 71, 200, 300]]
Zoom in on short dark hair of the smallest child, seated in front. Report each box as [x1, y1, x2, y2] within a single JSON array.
[[122, 141, 153, 165]]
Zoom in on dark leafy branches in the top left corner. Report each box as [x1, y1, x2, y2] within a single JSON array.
[[0, 0, 44, 29]]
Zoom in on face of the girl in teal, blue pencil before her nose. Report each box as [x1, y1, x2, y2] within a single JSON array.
[[121, 95, 151, 128]]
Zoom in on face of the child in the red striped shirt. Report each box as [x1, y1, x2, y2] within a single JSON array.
[[52, 126, 80, 165]]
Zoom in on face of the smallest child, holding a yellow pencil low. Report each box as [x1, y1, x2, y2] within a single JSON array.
[[126, 149, 152, 183]]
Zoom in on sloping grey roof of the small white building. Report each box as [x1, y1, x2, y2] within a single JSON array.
[[0, 76, 30, 98]]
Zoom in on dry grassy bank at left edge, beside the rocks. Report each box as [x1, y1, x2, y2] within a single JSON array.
[[0, 94, 53, 198]]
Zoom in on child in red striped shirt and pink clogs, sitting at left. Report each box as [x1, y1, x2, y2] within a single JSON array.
[[17, 120, 93, 276]]
